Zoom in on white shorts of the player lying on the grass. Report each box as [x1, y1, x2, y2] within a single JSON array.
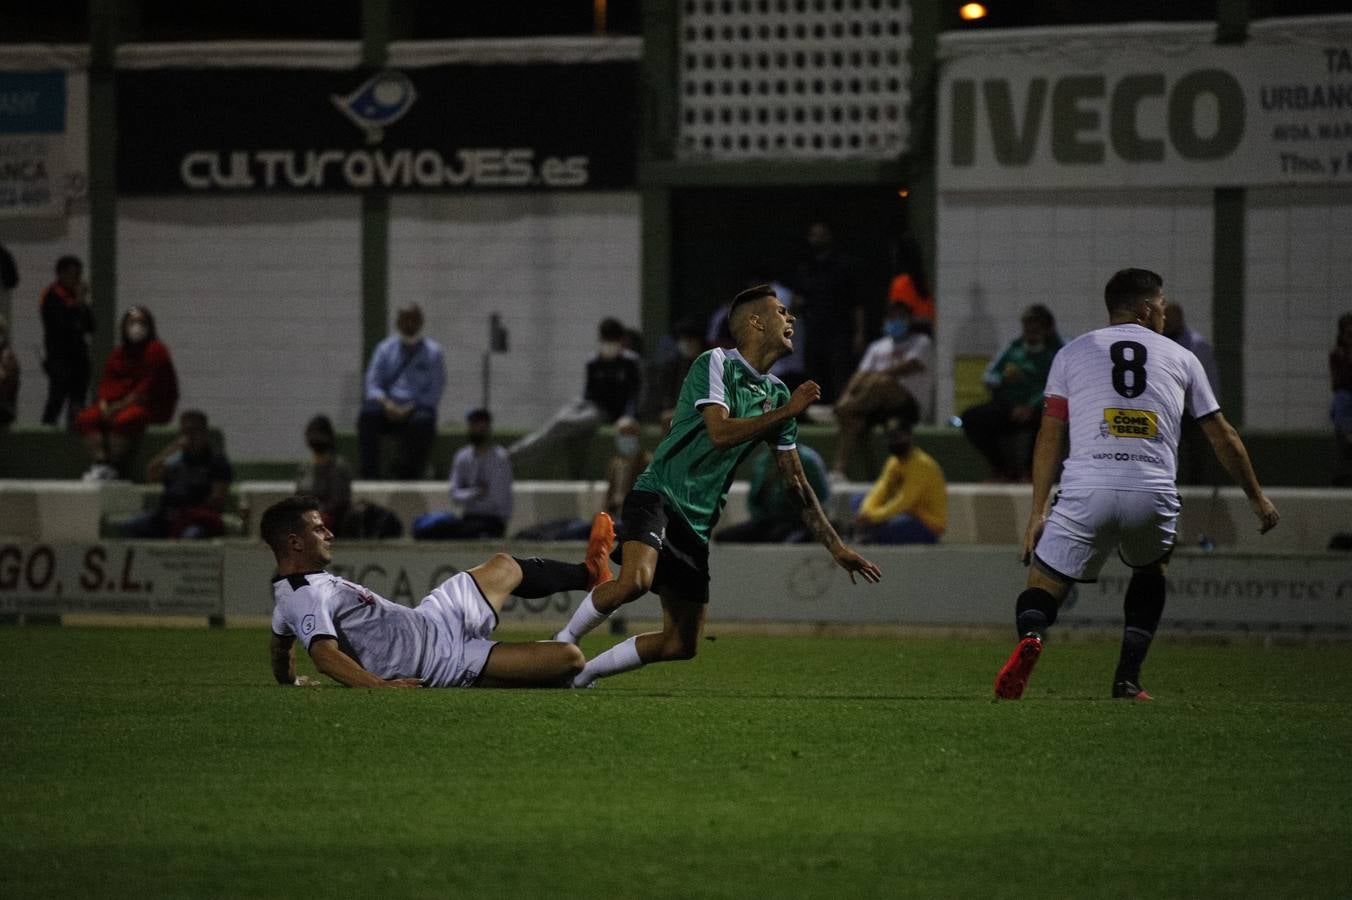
[[418, 572, 498, 688]]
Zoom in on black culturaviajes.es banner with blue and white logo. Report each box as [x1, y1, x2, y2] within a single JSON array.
[[118, 61, 638, 195]]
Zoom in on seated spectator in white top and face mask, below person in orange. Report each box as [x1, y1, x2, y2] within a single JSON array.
[[831, 301, 934, 481]]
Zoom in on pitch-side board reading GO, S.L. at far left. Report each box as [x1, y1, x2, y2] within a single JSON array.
[[0, 541, 223, 616]]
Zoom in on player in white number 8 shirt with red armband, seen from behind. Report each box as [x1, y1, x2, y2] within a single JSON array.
[[995, 269, 1279, 700]]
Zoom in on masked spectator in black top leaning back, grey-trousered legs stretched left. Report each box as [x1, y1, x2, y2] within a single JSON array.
[[510, 319, 644, 466]]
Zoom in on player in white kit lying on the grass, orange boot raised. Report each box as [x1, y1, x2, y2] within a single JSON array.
[[261, 497, 611, 688]]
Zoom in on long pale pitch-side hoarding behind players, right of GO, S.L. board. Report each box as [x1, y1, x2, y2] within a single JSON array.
[[226, 543, 1352, 632]]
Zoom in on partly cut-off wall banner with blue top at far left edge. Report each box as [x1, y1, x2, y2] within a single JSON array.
[[0, 72, 66, 218]]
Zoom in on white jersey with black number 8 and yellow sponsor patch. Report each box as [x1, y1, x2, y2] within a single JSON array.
[[1045, 324, 1220, 491]]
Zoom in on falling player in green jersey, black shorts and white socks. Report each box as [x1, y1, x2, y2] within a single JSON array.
[[556, 285, 882, 688]]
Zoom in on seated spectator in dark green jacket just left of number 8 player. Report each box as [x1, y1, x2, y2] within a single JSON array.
[[963, 303, 1061, 481]]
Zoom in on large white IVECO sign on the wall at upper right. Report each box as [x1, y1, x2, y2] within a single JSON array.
[[936, 16, 1352, 191]]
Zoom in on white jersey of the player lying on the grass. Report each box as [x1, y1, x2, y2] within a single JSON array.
[[272, 572, 435, 678]]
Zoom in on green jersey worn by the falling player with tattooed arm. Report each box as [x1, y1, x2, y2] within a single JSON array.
[[634, 347, 798, 543]]
